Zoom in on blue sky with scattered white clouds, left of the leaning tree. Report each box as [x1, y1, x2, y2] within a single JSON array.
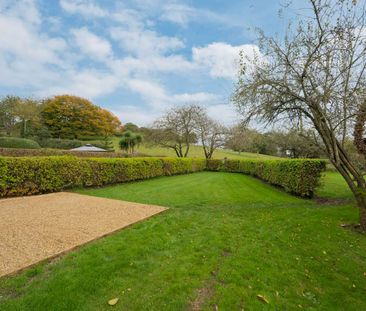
[[0, 0, 296, 126]]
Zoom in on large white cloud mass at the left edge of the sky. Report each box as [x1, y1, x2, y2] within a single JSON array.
[[0, 5, 67, 88]]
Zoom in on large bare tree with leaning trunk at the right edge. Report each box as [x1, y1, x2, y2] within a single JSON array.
[[233, 0, 366, 230]]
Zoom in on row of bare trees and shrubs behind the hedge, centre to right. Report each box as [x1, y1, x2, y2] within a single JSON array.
[[139, 104, 324, 159]]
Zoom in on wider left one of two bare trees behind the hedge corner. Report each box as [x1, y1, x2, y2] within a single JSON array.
[[149, 104, 202, 158]]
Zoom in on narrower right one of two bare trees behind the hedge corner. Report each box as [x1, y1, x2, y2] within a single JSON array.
[[195, 109, 226, 159]]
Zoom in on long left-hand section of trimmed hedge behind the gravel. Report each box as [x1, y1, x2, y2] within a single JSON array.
[[0, 156, 206, 197]]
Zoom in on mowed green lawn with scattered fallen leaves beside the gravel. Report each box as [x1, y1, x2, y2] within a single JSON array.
[[0, 172, 366, 311]]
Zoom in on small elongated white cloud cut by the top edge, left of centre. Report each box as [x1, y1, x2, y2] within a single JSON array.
[[60, 0, 108, 17]]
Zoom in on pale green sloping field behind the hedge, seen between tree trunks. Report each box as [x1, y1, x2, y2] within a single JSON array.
[[112, 137, 278, 159]]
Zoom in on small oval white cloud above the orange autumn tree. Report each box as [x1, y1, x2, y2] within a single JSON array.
[[71, 27, 112, 60]]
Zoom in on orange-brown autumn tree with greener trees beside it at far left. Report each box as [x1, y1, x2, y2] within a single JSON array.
[[0, 95, 122, 139]]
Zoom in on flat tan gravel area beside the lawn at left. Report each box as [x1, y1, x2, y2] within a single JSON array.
[[0, 192, 166, 277]]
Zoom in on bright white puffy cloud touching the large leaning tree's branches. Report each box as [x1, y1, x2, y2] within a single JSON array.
[[192, 42, 260, 79]]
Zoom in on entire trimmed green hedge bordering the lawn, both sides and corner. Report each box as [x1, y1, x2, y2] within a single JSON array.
[[0, 156, 326, 197]]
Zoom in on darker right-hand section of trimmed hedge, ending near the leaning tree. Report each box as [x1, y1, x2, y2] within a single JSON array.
[[207, 159, 326, 197]]
